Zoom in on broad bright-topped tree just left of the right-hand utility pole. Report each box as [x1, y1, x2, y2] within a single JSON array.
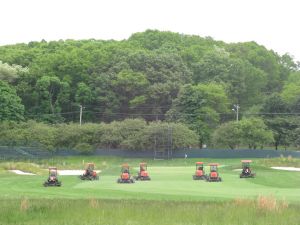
[[168, 82, 228, 145]]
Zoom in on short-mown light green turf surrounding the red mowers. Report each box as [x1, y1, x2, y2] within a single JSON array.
[[0, 157, 300, 202]]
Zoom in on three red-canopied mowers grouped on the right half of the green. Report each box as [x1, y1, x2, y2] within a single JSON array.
[[193, 160, 256, 182]]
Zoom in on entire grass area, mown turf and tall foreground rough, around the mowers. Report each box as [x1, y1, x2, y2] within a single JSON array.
[[0, 158, 300, 224]]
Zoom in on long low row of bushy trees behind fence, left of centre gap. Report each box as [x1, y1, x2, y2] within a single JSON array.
[[0, 119, 198, 153]]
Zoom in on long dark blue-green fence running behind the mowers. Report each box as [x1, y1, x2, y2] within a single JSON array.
[[0, 146, 300, 160]]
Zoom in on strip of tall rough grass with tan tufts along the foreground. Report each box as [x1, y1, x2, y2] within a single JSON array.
[[0, 199, 300, 225]]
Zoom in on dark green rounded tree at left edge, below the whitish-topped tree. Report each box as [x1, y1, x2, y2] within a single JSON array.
[[0, 80, 24, 121]]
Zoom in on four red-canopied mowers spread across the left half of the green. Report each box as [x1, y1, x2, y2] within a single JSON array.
[[44, 163, 151, 187]]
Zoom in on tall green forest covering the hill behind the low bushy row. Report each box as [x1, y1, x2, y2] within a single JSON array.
[[0, 30, 300, 149]]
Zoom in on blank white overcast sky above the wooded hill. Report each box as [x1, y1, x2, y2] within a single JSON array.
[[0, 0, 300, 61]]
